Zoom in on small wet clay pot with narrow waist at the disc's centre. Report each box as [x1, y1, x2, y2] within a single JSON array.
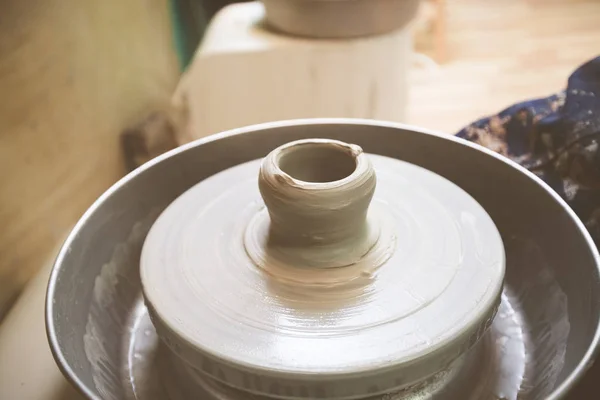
[[259, 139, 377, 268]]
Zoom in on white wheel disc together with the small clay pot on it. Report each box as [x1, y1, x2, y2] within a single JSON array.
[[141, 140, 504, 399]]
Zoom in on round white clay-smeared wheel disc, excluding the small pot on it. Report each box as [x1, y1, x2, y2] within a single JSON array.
[[141, 155, 505, 398]]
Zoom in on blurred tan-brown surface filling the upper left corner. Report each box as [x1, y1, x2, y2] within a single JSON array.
[[0, 0, 179, 316]]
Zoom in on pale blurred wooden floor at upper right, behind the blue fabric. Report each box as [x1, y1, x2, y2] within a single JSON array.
[[409, 0, 600, 133]]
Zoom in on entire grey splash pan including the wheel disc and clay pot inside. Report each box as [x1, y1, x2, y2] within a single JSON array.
[[46, 120, 600, 400]]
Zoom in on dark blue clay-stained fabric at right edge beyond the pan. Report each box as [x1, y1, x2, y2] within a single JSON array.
[[457, 57, 600, 245]]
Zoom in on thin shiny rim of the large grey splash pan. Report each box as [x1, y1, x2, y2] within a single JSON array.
[[45, 118, 600, 400]]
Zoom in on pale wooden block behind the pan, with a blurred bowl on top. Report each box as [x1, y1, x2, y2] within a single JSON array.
[[174, 2, 412, 140]]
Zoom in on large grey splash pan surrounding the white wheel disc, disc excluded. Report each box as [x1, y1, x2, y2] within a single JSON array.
[[46, 119, 600, 400]]
